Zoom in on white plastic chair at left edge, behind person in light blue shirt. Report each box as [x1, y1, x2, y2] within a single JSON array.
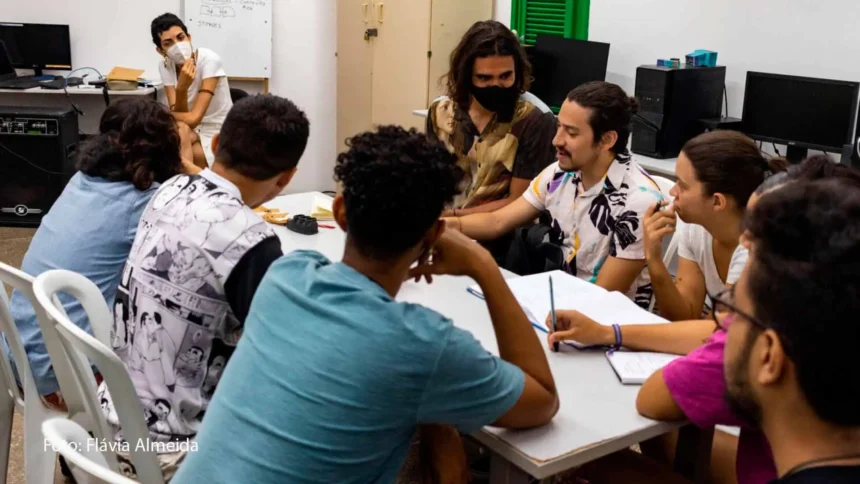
[[0, 263, 87, 484]]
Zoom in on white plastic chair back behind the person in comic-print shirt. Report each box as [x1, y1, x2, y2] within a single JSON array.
[[33, 270, 164, 483]]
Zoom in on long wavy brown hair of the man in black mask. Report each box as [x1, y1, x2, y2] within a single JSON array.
[[443, 20, 532, 112]]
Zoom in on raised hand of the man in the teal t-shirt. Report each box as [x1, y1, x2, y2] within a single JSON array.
[[409, 225, 495, 282]]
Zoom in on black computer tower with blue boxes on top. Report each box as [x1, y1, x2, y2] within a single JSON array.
[[631, 66, 726, 158]]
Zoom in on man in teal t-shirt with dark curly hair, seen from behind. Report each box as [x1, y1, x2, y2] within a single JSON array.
[[174, 126, 558, 484]]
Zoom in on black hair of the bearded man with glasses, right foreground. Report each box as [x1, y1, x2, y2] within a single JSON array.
[[749, 177, 860, 426]]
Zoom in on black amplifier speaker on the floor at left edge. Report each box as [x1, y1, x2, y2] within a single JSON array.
[[0, 106, 79, 227]]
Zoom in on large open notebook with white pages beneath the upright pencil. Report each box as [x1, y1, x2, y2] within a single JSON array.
[[469, 271, 668, 349]]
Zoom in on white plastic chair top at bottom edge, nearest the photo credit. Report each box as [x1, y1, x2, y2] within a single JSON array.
[[42, 418, 137, 484]]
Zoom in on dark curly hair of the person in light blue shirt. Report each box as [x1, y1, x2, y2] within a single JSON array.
[[77, 99, 182, 190]]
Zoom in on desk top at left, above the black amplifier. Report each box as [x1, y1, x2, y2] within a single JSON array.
[[0, 86, 160, 134]]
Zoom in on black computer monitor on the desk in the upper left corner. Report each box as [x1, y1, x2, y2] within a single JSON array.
[[0, 23, 72, 76]]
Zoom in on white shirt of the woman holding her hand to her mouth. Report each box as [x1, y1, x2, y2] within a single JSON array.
[[676, 224, 749, 314]]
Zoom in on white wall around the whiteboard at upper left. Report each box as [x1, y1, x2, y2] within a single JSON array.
[[0, 0, 337, 192]]
